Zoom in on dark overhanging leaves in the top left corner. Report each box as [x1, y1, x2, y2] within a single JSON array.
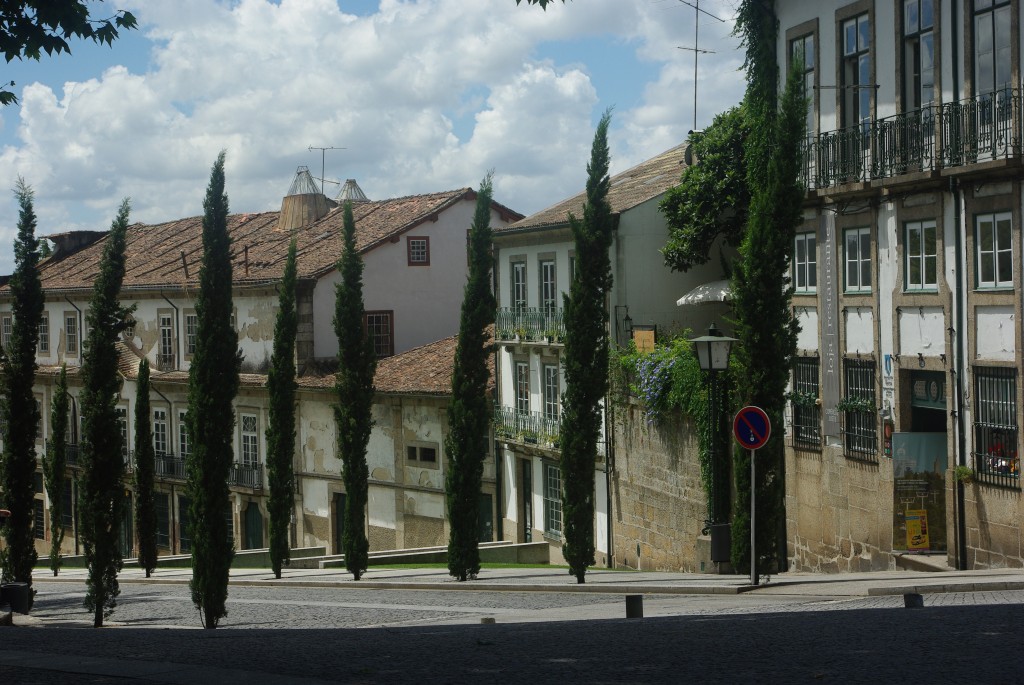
[[0, 0, 137, 104]]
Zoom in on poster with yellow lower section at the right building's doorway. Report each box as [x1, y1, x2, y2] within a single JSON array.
[[892, 433, 948, 553]]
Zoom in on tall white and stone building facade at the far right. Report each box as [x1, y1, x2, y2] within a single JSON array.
[[776, 0, 1024, 570]]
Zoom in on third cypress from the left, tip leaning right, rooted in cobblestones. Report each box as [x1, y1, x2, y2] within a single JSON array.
[[79, 200, 130, 628]]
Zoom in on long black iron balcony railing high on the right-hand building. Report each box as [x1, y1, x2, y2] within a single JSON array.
[[802, 89, 1024, 190]]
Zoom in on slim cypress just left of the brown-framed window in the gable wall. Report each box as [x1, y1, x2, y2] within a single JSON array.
[[334, 202, 377, 581]]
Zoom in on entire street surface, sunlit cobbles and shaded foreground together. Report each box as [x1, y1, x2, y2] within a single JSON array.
[[0, 583, 1024, 685]]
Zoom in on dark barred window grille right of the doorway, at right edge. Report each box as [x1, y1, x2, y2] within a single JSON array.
[[973, 367, 1020, 488]]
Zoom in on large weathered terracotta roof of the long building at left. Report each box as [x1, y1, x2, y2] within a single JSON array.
[[22, 188, 521, 292]]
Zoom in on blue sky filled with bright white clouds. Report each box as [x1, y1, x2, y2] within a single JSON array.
[[0, 0, 743, 273]]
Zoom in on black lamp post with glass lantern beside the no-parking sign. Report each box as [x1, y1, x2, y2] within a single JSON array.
[[690, 324, 736, 563]]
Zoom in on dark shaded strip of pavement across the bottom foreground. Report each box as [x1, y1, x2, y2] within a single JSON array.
[[0, 598, 1024, 685]]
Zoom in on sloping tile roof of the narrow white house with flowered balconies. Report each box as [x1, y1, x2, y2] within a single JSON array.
[[495, 144, 686, 234]]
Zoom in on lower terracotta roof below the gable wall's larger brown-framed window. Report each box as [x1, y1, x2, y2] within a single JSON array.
[[298, 336, 494, 395]]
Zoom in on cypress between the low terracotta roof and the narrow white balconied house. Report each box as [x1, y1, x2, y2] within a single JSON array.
[[444, 174, 497, 581]]
